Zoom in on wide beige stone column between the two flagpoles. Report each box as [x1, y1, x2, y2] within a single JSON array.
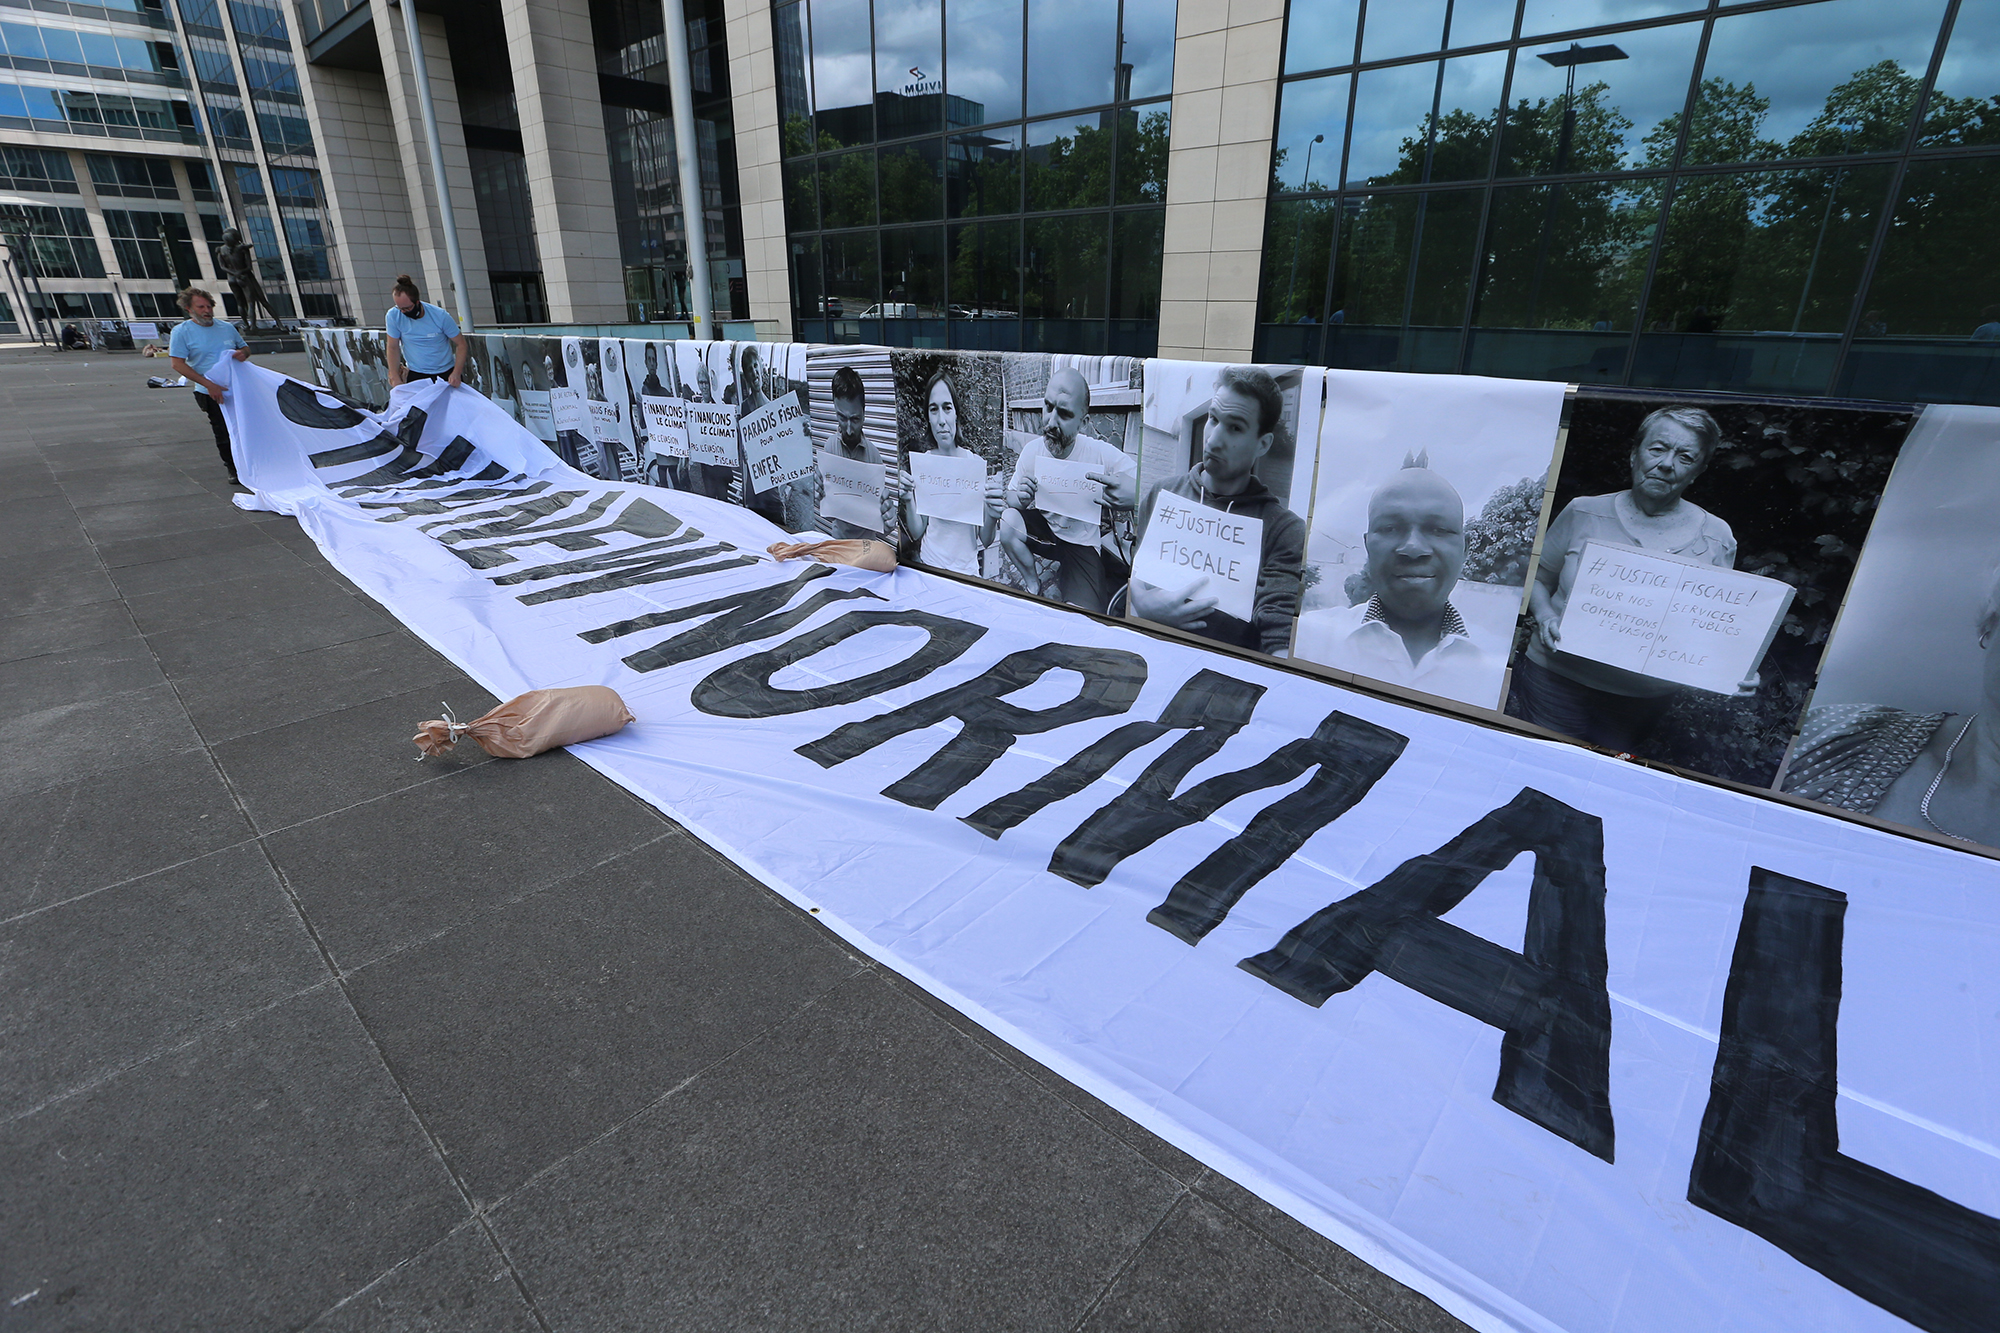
[[500, 0, 626, 324]]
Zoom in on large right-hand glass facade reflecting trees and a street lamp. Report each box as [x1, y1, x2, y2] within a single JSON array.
[[1256, 0, 2000, 402]]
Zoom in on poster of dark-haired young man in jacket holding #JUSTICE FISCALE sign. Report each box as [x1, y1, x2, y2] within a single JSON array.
[[1126, 360, 1322, 656]]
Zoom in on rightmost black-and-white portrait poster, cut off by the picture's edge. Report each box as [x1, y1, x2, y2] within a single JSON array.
[[1780, 406, 2000, 847]]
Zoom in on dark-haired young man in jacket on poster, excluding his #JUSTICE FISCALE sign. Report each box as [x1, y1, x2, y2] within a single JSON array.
[[1130, 366, 1306, 656]]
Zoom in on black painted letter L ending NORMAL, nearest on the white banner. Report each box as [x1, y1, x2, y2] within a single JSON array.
[[1688, 869, 2000, 1333]]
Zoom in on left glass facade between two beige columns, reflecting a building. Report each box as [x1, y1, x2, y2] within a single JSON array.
[[772, 0, 1176, 356]]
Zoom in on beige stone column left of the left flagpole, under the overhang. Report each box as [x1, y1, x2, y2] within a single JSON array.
[[292, 57, 422, 326]]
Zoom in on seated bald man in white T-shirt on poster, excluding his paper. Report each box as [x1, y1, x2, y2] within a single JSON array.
[[1000, 366, 1138, 612]]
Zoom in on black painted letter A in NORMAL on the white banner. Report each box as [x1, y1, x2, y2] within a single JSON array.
[[1238, 787, 1614, 1161]]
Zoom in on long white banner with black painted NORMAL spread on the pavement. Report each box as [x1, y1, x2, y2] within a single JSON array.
[[220, 362, 2000, 1333]]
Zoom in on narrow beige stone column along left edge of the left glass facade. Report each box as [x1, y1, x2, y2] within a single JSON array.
[[722, 0, 792, 342]]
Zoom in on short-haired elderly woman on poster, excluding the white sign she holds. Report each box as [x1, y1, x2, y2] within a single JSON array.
[[1508, 406, 1756, 753]]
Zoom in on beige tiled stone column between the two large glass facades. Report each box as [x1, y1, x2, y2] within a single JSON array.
[[1160, 0, 1284, 360]]
